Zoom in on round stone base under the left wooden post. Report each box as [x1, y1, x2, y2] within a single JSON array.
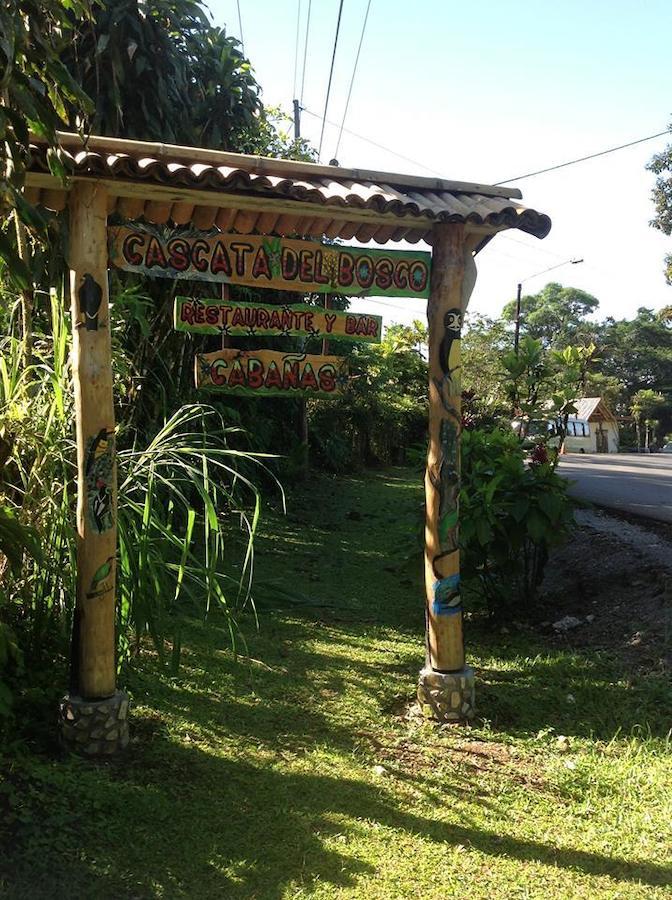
[[59, 691, 128, 758]]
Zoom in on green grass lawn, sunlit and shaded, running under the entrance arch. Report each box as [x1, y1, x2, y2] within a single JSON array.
[[0, 469, 672, 900]]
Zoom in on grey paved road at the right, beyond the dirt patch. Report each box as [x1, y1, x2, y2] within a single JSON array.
[[558, 453, 672, 522]]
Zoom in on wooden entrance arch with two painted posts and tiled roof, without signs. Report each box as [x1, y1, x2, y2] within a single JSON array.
[[26, 134, 551, 736]]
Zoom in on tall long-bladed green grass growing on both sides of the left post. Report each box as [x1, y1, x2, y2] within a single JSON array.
[[0, 291, 277, 715]]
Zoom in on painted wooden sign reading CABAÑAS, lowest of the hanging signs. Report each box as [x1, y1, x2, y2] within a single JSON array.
[[196, 348, 348, 397]]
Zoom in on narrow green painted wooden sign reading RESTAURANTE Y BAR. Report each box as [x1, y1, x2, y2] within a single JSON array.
[[174, 297, 383, 344]]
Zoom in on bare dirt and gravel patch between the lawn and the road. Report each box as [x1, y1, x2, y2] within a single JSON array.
[[537, 510, 672, 672]]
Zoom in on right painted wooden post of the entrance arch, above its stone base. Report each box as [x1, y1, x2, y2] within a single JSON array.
[[425, 224, 467, 672]]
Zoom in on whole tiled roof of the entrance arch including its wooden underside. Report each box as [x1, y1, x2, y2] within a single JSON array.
[[26, 133, 551, 243]]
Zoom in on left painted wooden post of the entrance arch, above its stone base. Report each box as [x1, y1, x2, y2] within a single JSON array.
[[69, 182, 117, 700]]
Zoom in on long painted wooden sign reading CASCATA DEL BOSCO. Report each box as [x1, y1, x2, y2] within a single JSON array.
[[109, 226, 431, 297]]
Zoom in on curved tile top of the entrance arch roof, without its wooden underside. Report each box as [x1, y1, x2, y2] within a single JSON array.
[[29, 134, 551, 239]]
